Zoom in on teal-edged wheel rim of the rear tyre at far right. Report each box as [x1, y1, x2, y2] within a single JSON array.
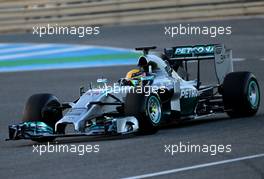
[[248, 81, 259, 109]]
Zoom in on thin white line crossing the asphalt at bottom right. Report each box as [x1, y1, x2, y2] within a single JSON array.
[[123, 153, 264, 179]]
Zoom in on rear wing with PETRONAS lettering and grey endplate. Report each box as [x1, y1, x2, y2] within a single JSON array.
[[164, 44, 233, 84]]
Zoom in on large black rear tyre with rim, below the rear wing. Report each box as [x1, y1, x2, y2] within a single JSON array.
[[223, 72, 260, 117]]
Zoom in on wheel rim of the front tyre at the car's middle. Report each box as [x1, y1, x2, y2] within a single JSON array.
[[147, 96, 161, 124]]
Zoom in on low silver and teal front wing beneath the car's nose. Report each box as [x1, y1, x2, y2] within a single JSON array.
[[6, 116, 139, 141]]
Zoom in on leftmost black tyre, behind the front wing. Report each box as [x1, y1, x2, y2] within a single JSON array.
[[22, 94, 62, 142]]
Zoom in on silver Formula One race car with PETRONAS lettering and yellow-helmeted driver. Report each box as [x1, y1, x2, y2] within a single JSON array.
[[7, 44, 260, 142]]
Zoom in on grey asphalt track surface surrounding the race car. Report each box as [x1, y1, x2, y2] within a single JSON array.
[[0, 18, 264, 179]]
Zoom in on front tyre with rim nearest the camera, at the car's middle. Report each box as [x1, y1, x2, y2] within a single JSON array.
[[124, 93, 162, 135]]
